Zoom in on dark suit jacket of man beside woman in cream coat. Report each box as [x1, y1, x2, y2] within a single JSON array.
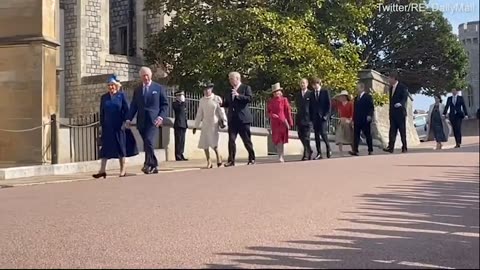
[[222, 84, 253, 124]]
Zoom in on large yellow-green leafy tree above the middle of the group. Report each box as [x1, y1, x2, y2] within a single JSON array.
[[145, 0, 376, 97]]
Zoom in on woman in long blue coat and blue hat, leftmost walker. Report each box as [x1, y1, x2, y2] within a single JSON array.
[[93, 75, 138, 178]]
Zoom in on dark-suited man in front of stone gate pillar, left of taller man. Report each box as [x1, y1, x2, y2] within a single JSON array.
[[349, 82, 375, 156]]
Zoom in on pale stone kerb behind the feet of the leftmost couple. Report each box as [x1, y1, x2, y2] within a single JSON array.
[[0, 149, 166, 180]]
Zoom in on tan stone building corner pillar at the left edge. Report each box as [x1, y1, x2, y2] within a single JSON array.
[[0, 0, 59, 164]]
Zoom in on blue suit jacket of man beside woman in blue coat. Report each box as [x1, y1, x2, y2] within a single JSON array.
[[128, 81, 168, 128]]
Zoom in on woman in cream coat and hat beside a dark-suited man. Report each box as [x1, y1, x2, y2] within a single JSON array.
[[193, 84, 227, 169]]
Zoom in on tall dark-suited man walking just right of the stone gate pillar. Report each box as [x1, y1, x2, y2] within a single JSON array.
[[383, 72, 408, 153]]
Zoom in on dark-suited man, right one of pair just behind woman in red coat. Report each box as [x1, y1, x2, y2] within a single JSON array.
[[310, 78, 332, 159]]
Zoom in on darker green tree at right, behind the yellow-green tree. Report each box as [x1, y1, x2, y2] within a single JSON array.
[[357, 0, 468, 95]]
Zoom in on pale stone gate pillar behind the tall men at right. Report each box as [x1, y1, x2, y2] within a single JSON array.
[[358, 69, 420, 148]]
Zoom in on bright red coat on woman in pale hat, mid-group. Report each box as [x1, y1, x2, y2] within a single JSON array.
[[267, 97, 293, 144]]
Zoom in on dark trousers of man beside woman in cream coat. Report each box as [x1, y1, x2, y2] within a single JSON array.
[[228, 123, 255, 163]]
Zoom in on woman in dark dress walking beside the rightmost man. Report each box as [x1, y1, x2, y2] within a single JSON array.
[[427, 95, 450, 150]]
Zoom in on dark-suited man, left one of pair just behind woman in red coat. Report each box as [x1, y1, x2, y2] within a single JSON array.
[[295, 79, 312, 160]]
